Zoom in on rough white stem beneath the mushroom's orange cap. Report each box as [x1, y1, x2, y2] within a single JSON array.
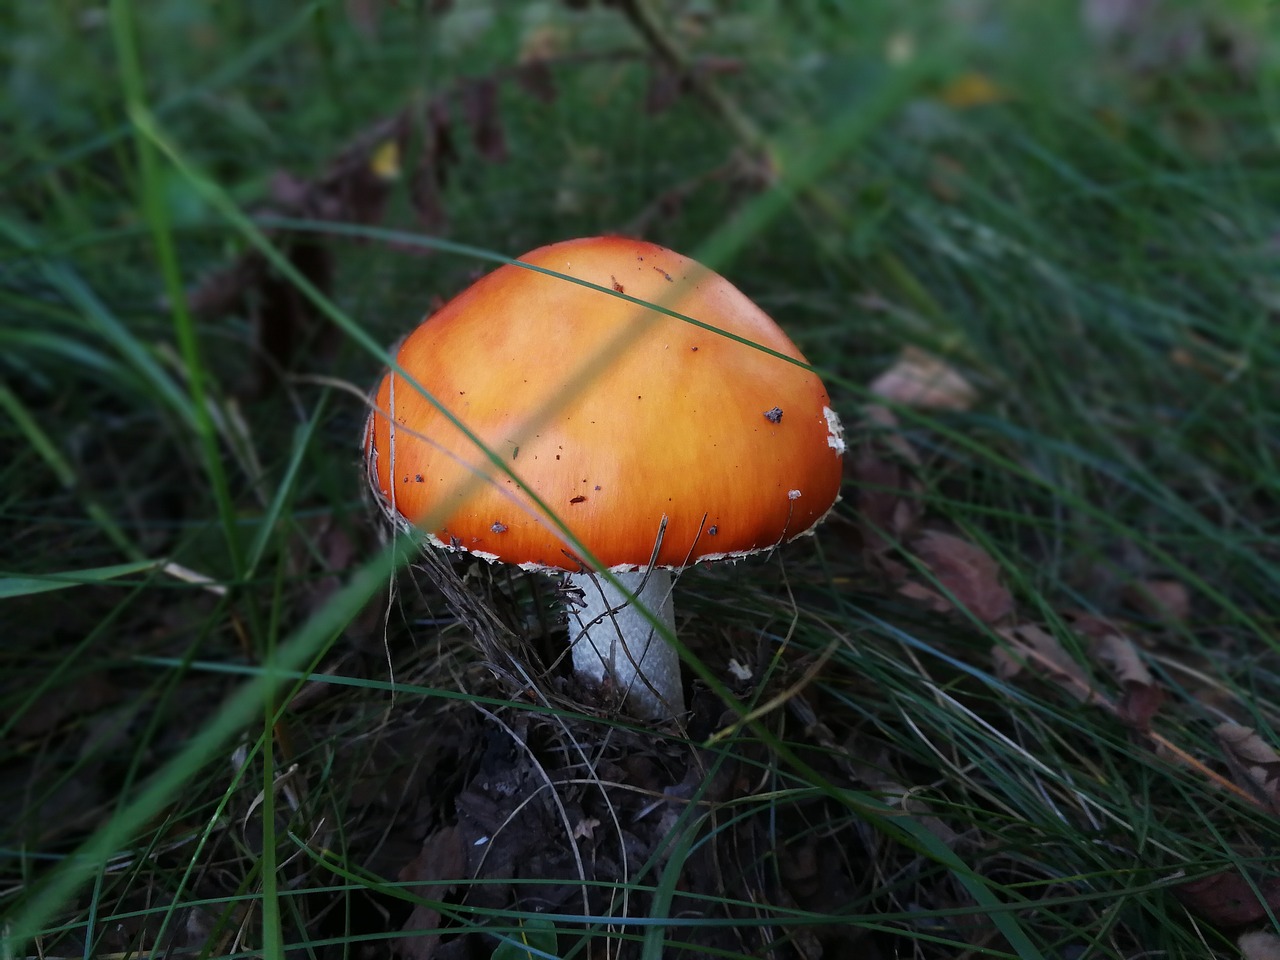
[[568, 570, 685, 719]]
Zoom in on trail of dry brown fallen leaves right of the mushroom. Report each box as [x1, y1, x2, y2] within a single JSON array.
[[846, 347, 1280, 942]]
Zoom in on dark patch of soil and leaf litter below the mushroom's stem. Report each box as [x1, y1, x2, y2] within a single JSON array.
[[384, 691, 863, 960]]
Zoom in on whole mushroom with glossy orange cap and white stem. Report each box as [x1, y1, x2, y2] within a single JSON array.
[[365, 237, 845, 719]]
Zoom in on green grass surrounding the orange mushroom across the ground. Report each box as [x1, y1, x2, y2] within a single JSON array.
[[0, 1, 1280, 957]]
